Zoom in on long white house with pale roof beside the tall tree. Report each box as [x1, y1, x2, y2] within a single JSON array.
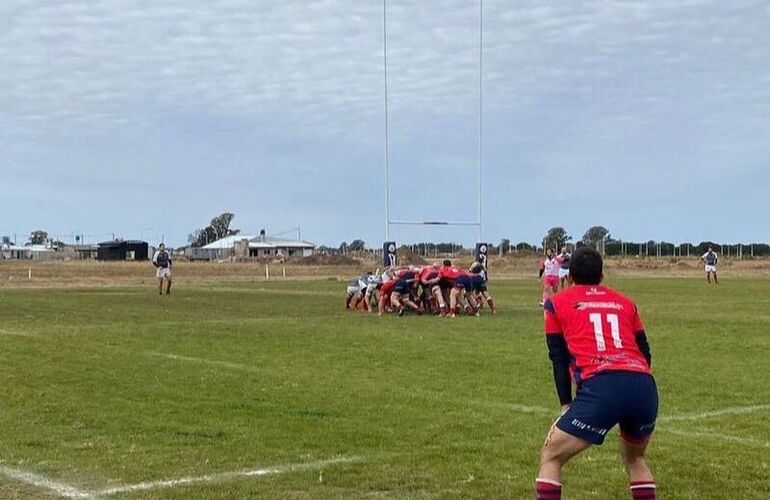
[[203, 230, 315, 259]]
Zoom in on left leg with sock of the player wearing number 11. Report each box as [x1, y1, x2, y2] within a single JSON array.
[[535, 424, 591, 500]]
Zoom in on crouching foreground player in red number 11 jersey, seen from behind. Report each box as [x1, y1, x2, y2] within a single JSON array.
[[536, 248, 658, 500]]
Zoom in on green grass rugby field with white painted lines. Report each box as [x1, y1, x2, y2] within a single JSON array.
[[0, 278, 770, 499]]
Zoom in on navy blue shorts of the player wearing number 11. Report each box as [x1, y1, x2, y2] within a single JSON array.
[[556, 372, 658, 444]]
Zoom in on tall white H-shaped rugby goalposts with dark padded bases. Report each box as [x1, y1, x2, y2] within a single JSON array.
[[382, 0, 488, 267]]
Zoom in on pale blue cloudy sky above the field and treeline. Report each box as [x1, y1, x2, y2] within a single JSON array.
[[0, 0, 770, 247]]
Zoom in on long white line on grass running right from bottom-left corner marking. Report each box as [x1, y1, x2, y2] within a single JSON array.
[[98, 457, 361, 496]]
